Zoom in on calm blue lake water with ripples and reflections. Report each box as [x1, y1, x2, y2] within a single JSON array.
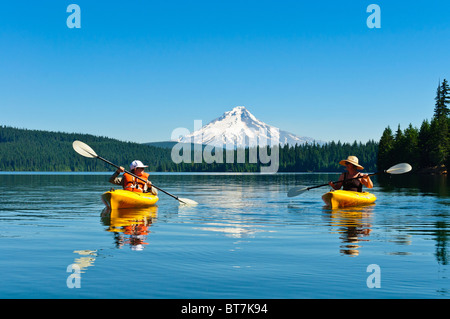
[[0, 173, 450, 299]]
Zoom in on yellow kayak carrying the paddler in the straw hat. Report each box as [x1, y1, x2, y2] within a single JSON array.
[[322, 190, 377, 208]]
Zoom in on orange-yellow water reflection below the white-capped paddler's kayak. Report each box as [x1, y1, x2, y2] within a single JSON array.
[[101, 206, 158, 251]]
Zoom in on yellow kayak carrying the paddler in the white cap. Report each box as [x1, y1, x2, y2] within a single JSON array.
[[102, 189, 158, 209]]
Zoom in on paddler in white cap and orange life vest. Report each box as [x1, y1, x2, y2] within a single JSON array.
[[109, 160, 158, 195]]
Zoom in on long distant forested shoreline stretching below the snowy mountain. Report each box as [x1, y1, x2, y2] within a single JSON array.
[[0, 126, 378, 172]]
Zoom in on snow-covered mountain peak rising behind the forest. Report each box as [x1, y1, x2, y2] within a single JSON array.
[[178, 106, 323, 148]]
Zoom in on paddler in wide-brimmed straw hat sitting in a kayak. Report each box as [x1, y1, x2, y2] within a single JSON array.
[[328, 156, 373, 192]]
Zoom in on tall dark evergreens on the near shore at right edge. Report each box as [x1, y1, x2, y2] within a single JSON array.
[[377, 79, 450, 171]]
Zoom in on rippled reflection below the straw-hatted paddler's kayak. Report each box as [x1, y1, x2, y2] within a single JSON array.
[[324, 204, 375, 256]]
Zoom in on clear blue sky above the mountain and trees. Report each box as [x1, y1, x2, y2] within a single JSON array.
[[0, 0, 450, 142]]
